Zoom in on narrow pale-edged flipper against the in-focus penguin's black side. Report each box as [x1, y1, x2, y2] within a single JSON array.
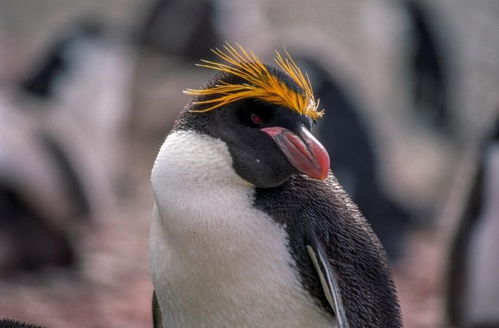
[[306, 232, 350, 328]]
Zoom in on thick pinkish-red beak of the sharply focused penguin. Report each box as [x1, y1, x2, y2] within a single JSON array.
[[261, 126, 329, 180]]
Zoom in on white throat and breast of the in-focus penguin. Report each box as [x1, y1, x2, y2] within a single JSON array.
[[150, 131, 333, 328]]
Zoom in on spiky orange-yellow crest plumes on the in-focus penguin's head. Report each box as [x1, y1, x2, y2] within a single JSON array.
[[184, 43, 323, 119]]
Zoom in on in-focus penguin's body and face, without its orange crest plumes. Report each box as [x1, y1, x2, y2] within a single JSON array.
[[150, 44, 401, 328]]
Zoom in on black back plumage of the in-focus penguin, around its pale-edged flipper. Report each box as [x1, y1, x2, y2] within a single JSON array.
[[254, 174, 402, 328]]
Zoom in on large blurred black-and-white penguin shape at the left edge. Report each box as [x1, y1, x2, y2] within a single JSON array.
[[0, 20, 133, 274]]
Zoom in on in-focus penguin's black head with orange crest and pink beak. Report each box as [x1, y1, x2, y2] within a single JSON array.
[[175, 45, 329, 188]]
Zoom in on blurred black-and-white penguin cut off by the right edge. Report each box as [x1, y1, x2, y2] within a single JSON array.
[[446, 116, 499, 328]]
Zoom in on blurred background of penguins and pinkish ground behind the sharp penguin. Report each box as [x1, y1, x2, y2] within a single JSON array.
[[0, 0, 499, 328]]
